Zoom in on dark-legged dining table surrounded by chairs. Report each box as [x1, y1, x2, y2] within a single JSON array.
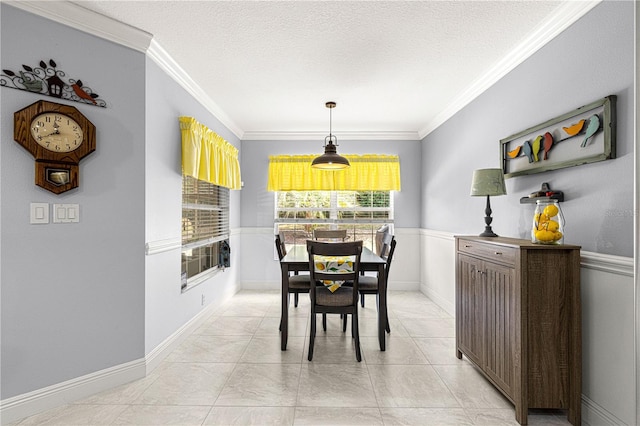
[[280, 245, 387, 351]]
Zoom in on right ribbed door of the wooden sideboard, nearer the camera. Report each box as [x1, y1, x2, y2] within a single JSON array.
[[482, 262, 520, 398]]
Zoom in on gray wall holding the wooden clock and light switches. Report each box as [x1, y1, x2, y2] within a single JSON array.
[[0, 3, 145, 399]]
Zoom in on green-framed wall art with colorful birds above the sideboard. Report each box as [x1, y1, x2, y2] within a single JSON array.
[[500, 95, 616, 178]]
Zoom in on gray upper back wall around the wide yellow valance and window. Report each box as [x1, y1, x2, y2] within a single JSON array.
[[241, 140, 420, 228]]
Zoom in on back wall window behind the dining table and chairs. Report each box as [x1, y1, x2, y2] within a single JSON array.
[[275, 191, 393, 250]]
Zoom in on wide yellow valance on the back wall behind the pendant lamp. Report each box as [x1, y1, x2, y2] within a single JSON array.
[[267, 154, 400, 191]]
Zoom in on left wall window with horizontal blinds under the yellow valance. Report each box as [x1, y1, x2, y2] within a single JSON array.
[[182, 175, 229, 291]]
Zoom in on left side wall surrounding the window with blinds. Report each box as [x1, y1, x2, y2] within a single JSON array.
[[145, 59, 240, 354]]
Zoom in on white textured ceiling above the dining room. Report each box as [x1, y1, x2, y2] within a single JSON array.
[[26, 1, 594, 139]]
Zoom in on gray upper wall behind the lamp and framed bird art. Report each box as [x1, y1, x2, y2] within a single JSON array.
[[421, 2, 634, 257]]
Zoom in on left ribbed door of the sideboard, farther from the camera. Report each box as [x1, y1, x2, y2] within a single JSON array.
[[456, 254, 485, 366]]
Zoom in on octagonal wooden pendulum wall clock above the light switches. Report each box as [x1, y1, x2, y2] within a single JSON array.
[[13, 101, 96, 194]]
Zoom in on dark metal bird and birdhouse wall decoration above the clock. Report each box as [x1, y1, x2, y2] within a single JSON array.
[[0, 59, 107, 108]]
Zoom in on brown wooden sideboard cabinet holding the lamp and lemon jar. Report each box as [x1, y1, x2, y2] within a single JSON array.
[[456, 236, 582, 425]]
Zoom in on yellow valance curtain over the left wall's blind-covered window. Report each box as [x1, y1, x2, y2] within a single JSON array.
[[180, 117, 241, 189]]
